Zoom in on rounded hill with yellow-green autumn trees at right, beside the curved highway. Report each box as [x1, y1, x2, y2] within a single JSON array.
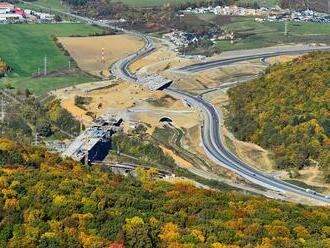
[[227, 53, 330, 181]]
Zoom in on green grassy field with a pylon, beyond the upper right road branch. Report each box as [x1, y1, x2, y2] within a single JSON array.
[[216, 18, 330, 51]]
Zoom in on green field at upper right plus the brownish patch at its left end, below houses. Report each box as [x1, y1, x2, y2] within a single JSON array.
[[181, 14, 330, 52]]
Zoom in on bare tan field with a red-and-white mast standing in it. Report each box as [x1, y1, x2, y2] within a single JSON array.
[[58, 34, 144, 76]]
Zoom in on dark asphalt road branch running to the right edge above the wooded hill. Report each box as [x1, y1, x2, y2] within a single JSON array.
[[176, 46, 330, 73]]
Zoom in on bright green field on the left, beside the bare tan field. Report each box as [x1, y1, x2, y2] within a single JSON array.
[[0, 24, 102, 93]]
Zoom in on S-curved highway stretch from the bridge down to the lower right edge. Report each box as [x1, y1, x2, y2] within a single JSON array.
[[165, 88, 330, 204]]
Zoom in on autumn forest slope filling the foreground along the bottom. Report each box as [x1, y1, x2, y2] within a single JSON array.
[[0, 138, 330, 248]]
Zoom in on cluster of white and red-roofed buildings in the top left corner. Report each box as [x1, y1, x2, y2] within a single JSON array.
[[0, 3, 55, 24]]
